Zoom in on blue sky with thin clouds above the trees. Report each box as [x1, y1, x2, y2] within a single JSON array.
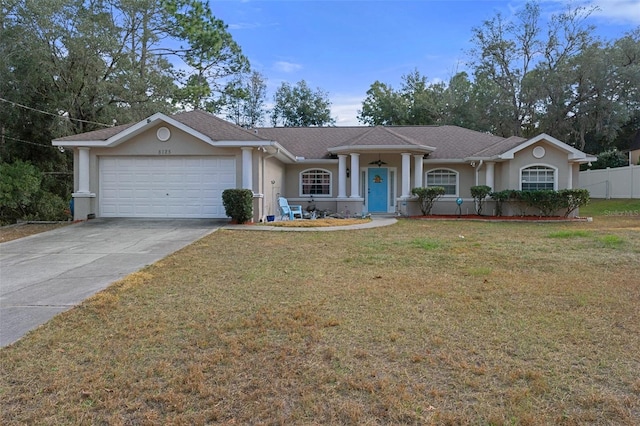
[[210, 0, 640, 126]]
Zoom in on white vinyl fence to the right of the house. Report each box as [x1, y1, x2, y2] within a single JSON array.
[[578, 165, 640, 199]]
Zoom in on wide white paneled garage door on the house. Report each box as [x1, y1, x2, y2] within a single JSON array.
[[99, 157, 236, 218]]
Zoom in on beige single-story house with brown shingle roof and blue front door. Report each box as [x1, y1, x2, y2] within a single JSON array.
[[53, 111, 596, 221]]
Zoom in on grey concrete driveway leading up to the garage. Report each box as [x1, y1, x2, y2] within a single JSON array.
[[0, 219, 228, 347]]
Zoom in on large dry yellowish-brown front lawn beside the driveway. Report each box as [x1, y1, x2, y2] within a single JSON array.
[[0, 218, 640, 425]]
